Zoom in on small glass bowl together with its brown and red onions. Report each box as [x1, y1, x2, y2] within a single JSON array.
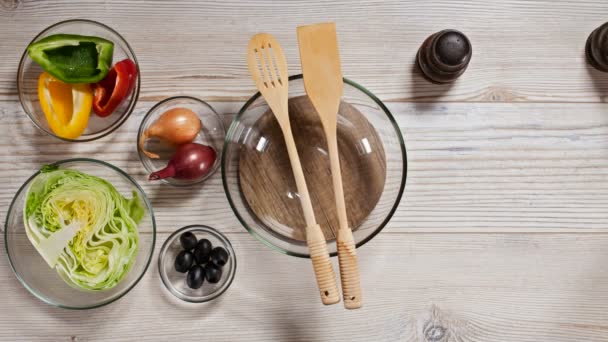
[[137, 96, 225, 186]]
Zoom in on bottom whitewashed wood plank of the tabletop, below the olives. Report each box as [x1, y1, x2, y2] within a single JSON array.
[[0, 233, 608, 342]]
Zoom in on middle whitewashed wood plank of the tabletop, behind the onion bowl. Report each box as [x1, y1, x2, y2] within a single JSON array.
[[0, 101, 608, 232]]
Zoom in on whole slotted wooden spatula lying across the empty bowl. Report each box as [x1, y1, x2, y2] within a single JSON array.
[[247, 33, 340, 305]]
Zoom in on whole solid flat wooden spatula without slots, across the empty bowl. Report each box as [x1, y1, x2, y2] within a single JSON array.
[[298, 23, 362, 309]]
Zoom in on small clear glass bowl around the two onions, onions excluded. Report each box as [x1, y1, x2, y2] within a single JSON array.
[[136, 96, 226, 186]]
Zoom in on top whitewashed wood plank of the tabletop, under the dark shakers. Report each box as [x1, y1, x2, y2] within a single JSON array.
[[0, 0, 608, 102]]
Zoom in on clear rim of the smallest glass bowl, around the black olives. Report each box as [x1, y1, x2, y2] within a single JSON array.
[[158, 224, 237, 303]]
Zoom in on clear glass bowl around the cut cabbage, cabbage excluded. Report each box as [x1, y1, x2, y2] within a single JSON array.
[[4, 158, 156, 309]]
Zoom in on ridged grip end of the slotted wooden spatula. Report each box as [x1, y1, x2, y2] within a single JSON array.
[[306, 224, 340, 305]]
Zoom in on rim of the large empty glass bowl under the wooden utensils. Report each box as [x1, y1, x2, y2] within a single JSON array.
[[222, 74, 407, 259]]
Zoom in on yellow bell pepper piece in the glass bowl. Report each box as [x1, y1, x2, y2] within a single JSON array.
[[38, 72, 93, 139]]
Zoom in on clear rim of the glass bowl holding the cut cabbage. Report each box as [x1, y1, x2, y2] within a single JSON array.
[[4, 158, 156, 310]]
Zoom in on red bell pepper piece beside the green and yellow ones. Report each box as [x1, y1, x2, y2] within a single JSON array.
[[93, 59, 137, 117]]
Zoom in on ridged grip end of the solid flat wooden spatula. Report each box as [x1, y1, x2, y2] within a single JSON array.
[[337, 228, 363, 309]]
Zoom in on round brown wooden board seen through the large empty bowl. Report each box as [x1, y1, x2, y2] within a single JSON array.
[[239, 96, 386, 241]]
